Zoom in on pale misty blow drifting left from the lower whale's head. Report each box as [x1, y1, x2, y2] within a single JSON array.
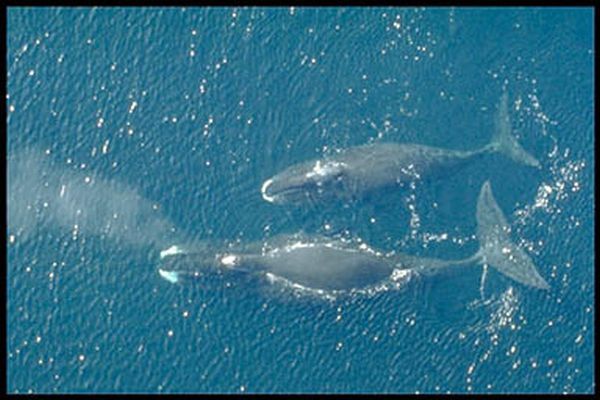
[[7, 149, 174, 247]]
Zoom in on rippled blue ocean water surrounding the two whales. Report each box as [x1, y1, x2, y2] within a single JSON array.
[[6, 8, 595, 393]]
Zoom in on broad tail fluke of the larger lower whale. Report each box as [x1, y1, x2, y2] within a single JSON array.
[[477, 181, 550, 289]]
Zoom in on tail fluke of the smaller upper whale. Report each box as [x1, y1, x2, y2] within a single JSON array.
[[488, 91, 541, 168]]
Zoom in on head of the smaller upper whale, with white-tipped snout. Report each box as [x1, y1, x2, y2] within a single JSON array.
[[261, 160, 346, 204]]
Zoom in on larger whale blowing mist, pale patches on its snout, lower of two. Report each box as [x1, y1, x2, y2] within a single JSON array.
[[158, 182, 549, 291]]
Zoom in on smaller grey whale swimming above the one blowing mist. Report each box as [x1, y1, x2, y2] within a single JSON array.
[[261, 92, 540, 204]]
